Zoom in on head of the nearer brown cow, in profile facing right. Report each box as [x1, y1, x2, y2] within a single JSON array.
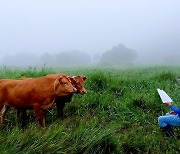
[[54, 76, 77, 96]]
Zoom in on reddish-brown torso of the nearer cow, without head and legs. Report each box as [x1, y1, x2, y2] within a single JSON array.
[[0, 78, 54, 108]]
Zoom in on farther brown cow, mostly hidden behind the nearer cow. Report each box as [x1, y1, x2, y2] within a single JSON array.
[[47, 74, 87, 118]]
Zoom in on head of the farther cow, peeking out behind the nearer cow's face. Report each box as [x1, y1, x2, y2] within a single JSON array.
[[71, 76, 87, 94]]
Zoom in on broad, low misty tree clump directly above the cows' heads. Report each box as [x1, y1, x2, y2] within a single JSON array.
[[55, 50, 91, 66]]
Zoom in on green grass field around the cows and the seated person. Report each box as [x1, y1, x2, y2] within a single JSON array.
[[0, 66, 180, 154]]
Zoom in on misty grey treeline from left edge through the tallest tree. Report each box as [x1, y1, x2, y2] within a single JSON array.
[[2, 44, 137, 66]]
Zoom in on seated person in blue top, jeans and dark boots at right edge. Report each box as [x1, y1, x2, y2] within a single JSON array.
[[158, 102, 180, 137]]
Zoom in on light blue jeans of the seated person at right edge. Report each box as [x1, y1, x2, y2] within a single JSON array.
[[158, 113, 180, 127]]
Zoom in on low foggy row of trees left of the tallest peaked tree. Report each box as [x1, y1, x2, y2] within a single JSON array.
[[3, 51, 91, 66]]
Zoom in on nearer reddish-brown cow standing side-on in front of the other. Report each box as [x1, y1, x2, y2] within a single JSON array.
[[0, 75, 77, 126]]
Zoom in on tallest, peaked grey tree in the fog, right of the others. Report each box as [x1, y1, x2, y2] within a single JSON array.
[[100, 44, 137, 65]]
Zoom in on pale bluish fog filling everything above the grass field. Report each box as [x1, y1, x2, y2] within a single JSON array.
[[0, 0, 180, 66]]
